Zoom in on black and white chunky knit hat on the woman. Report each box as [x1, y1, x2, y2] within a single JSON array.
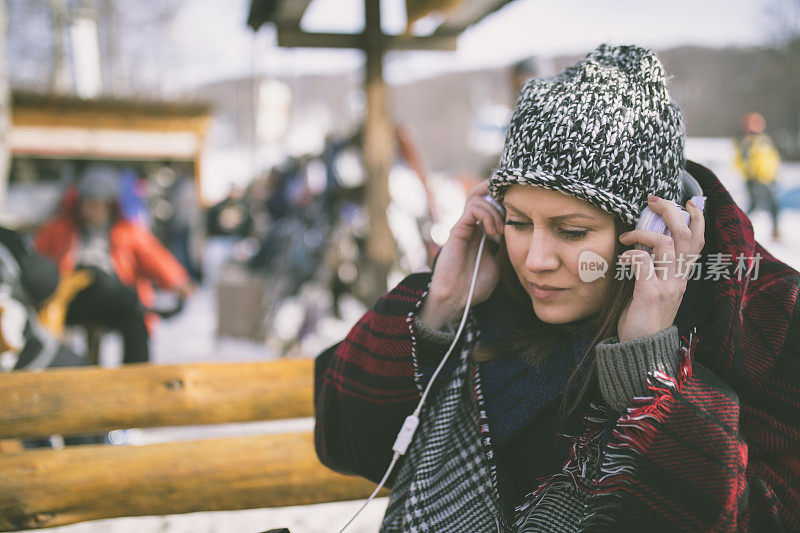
[[489, 44, 685, 224]]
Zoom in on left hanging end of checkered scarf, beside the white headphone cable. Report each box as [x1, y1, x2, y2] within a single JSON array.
[[381, 322, 504, 533]]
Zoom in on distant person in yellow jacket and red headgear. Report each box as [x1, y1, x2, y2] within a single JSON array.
[[735, 113, 781, 239]]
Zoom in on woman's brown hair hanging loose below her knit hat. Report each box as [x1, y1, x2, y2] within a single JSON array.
[[472, 218, 634, 424]]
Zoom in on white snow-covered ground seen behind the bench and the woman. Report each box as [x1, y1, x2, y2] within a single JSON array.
[[23, 139, 800, 533]]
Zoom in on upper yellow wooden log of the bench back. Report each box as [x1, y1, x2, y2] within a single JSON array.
[[0, 359, 314, 438]]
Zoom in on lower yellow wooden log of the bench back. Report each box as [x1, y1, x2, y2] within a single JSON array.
[[0, 433, 386, 531]]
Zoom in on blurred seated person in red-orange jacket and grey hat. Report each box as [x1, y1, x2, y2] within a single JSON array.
[[35, 163, 193, 363]]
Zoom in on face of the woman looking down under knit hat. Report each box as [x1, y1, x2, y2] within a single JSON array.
[[503, 185, 617, 324]]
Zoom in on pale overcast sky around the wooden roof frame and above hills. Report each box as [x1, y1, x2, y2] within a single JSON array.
[[173, 0, 780, 85]]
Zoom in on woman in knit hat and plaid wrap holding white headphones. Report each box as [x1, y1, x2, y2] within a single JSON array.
[[315, 45, 800, 532]]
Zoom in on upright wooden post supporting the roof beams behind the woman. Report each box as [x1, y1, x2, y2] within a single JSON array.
[[363, 0, 396, 300]]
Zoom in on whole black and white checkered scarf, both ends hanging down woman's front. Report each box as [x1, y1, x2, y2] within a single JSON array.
[[381, 310, 624, 533]]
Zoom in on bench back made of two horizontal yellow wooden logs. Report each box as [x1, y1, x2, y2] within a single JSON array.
[[0, 360, 388, 531]]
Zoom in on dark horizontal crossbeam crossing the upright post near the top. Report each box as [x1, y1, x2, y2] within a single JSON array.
[[278, 26, 458, 51]]
